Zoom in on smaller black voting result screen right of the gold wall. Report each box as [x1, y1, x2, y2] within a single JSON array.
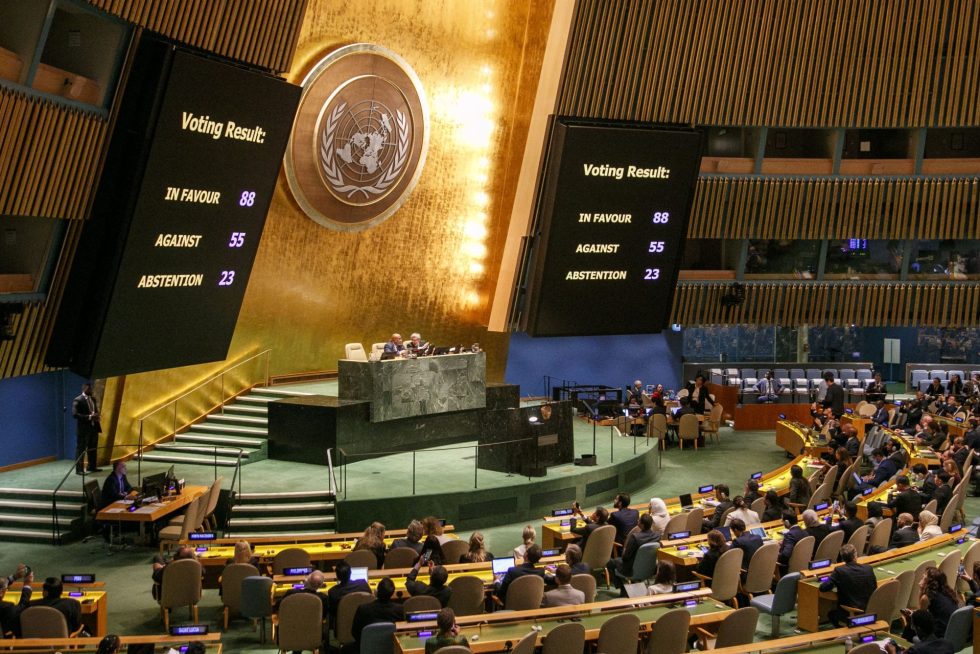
[[521, 118, 701, 336]]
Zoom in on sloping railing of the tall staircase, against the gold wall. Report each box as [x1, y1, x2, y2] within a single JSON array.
[[136, 349, 272, 466]]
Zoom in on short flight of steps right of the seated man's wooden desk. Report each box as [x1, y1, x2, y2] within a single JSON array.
[[225, 491, 337, 538]]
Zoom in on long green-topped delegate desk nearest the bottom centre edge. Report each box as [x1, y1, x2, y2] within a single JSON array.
[[395, 588, 734, 654]]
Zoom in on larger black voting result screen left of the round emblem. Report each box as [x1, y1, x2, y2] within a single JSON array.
[[49, 47, 301, 377]]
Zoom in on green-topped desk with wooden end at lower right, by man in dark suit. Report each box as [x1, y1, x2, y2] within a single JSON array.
[[796, 531, 977, 631]]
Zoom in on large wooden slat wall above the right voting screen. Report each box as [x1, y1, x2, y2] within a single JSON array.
[[557, 0, 968, 127]]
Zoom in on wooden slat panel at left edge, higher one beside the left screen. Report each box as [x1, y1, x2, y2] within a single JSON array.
[[0, 87, 107, 219]]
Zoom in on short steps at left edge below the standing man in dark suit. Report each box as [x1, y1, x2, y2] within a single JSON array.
[[0, 488, 85, 545]]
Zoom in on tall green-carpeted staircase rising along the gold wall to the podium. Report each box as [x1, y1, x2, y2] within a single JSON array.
[[143, 387, 309, 467]]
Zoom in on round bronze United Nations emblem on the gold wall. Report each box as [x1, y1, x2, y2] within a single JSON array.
[[285, 43, 429, 231]]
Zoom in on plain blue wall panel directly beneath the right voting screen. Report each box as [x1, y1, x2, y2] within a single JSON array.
[[505, 332, 682, 396]]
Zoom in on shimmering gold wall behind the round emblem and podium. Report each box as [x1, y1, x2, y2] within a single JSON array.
[[104, 0, 553, 452]]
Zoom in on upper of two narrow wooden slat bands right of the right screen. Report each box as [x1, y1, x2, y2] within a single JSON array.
[[687, 177, 980, 240]]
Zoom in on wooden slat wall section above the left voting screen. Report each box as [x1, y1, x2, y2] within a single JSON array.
[[88, 0, 307, 73]]
